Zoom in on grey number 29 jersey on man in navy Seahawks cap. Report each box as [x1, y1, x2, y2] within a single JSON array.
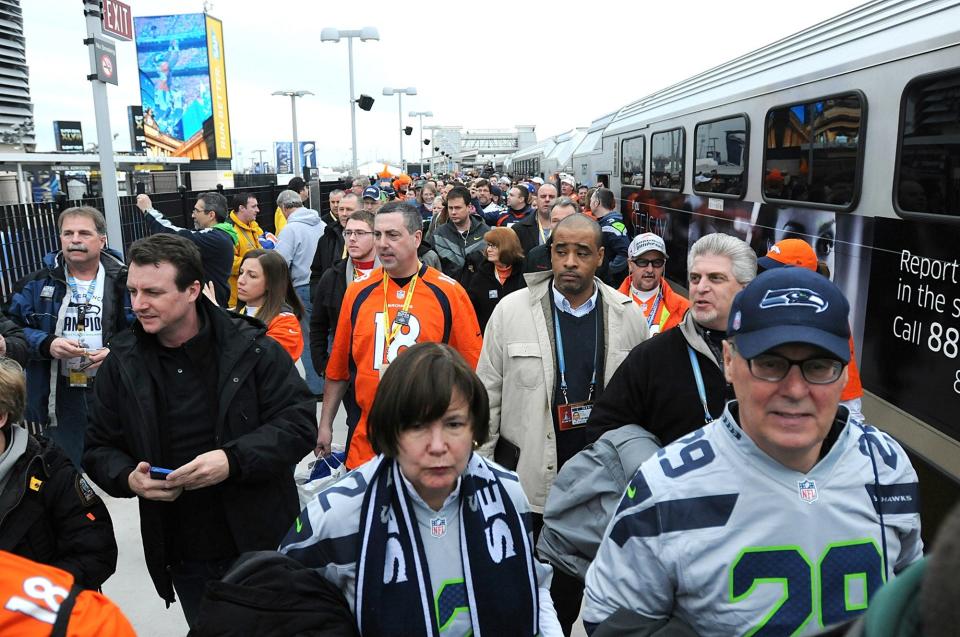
[[583, 403, 923, 637]]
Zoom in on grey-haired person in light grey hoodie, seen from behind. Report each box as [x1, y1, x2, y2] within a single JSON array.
[[277, 190, 326, 395]]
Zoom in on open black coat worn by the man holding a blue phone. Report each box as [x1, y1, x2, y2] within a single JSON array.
[[83, 297, 317, 603]]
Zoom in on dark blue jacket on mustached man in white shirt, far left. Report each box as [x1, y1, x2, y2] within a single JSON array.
[[9, 249, 133, 426]]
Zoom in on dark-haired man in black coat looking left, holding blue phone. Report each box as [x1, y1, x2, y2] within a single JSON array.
[[84, 234, 317, 624]]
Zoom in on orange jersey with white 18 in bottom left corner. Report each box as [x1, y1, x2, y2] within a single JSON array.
[[0, 551, 137, 637]]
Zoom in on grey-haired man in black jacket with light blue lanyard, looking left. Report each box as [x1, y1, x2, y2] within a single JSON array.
[[587, 233, 757, 445]]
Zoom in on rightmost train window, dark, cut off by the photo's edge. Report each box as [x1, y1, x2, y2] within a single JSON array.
[[894, 69, 960, 217]]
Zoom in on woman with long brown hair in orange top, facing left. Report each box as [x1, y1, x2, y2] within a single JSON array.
[[236, 250, 303, 366]]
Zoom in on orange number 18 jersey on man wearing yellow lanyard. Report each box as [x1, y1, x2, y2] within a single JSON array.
[[326, 265, 483, 469]]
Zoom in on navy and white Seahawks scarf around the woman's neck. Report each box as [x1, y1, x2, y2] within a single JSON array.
[[354, 454, 540, 637]]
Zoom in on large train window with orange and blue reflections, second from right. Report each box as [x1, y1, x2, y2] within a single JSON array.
[[763, 93, 864, 208]]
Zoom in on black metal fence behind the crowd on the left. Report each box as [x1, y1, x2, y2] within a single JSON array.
[[0, 182, 349, 306]]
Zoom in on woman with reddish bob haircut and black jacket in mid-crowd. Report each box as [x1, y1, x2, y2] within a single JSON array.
[[467, 228, 527, 332]]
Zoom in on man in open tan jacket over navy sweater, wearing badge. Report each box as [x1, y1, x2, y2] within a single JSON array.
[[477, 214, 649, 630]]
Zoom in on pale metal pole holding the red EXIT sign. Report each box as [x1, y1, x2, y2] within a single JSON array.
[[84, 0, 123, 255]]
